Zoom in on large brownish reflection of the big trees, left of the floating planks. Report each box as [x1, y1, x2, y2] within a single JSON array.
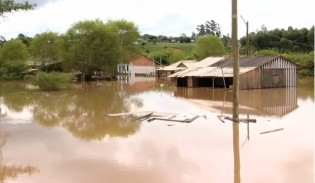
[[33, 86, 142, 140]]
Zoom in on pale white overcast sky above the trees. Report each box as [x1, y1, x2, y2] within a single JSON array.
[[0, 0, 315, 39]]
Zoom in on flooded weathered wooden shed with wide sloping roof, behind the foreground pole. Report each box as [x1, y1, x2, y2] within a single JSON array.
[[169, 56, 296, 89]]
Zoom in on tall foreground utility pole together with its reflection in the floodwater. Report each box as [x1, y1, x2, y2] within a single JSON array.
[[232, 0, 241, 183]]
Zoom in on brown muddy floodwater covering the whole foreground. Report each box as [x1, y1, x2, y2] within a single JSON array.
[[0, 78, 314, 183]]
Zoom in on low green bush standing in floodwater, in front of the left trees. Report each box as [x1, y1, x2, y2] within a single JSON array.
[[26, 72, 75, 90]]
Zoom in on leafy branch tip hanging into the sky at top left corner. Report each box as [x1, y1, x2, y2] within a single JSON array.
[[0, 0, 36, 16]]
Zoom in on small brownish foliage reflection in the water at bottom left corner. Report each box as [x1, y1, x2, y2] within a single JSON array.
[[0, 131, 39, 182]]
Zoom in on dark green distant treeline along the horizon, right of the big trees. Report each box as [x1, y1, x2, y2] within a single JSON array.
[[142, 24, 314, 54]]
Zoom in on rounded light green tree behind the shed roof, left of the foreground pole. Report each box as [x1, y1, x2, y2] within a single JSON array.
[[194, 35, 226, 60]]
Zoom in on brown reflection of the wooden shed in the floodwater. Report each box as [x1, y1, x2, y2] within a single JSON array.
[[175, 87, 298, 117]]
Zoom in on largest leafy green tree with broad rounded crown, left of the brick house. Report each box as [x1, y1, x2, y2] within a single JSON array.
[[63, 20, 121, 80]]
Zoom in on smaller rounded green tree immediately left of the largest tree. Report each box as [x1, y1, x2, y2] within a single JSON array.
[[30, 32, 62, 66]]
